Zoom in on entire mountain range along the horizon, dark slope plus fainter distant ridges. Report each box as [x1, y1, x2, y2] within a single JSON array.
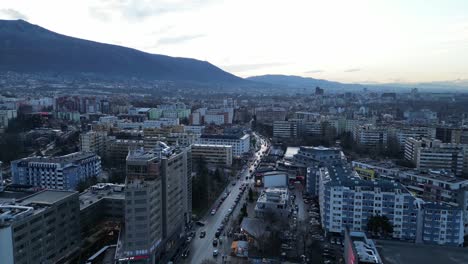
[[0, 20, 468, 91]]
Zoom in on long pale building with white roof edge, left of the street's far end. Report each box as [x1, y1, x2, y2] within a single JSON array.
[[192, 144, 232, 166]]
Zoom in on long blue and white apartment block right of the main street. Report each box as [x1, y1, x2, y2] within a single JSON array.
[[318, 166, 464, 246]]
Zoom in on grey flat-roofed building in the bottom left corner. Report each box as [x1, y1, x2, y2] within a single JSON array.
[[0, 190, 81, 264]]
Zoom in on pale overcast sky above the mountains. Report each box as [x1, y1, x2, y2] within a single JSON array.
[[0, 0, 468, 83]]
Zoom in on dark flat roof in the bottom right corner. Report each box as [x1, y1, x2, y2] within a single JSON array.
[[375, 240, 468, 264]]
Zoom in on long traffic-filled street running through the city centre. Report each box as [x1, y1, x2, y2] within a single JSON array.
[[184, 137, 268, 264]]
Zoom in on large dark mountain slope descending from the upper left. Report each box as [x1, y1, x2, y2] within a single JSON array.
[[0, 20, 249, 84]]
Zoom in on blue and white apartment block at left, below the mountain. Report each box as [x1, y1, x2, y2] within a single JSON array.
[[11, 152, 101, 190]]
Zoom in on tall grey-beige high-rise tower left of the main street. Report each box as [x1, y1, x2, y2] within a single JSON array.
[[116, 142, 191, 263]]
